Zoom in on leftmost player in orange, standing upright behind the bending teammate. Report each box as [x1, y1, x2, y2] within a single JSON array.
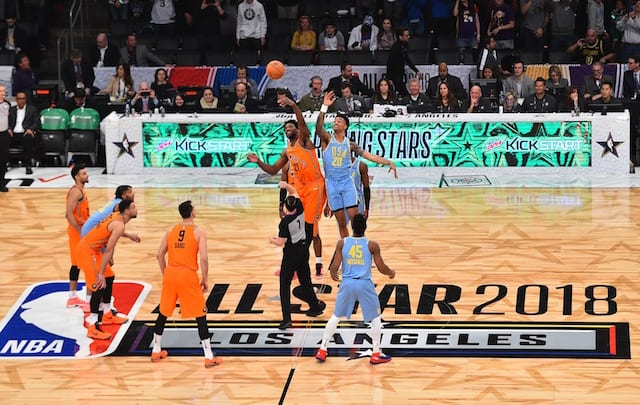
[[66, 164, 89, 312]]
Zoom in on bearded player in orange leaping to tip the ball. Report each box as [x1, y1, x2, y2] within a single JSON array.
[[248, 94, 326, 275]]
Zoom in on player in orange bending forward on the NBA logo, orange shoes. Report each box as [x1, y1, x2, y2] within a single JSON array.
[[75, 200, 138, 339]]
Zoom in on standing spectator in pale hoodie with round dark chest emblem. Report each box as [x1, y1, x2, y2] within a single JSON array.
[[236, 0, 267, 49]]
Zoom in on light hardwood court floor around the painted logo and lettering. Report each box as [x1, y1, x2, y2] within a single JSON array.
[[0, 188, 640, 405]]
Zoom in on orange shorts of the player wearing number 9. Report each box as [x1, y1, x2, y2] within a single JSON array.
[[160, 266, 207, 319]]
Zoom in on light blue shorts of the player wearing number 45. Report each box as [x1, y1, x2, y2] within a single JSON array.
[[333, 278, 380, 322]]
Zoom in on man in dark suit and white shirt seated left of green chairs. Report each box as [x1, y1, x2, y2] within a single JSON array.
[[9, 91, 40, 174]]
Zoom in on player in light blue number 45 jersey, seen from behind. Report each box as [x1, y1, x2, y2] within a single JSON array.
[[315, 214, 396, 364]]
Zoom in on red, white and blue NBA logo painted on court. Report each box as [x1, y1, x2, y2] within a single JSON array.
[[0, 281, 151, 358]]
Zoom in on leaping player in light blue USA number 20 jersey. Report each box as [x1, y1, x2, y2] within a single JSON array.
[[316, 91, 398, 238]]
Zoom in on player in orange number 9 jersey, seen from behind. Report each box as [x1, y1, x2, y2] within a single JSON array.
[[151, 201, 222, 368]]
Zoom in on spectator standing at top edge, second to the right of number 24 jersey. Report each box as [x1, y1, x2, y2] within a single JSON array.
[[518, 0, 551, 51]]
